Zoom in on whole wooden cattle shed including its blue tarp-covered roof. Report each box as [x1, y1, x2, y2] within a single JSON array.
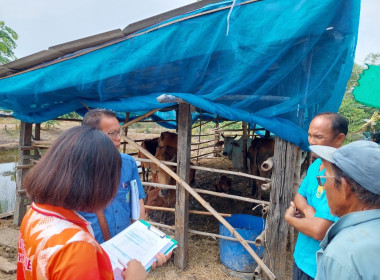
[[0, 0, 360, 279]]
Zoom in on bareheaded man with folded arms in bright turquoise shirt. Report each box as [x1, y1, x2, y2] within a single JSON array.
[[285, 113, 348, 280]]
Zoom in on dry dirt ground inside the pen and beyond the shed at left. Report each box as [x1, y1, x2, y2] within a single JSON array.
[[0, 119, 290, 280]]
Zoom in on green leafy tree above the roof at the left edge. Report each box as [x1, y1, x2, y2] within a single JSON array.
[[0, 21, 18, 65]]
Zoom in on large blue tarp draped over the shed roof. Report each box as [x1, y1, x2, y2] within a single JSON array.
[[0, 0, 360, 148]]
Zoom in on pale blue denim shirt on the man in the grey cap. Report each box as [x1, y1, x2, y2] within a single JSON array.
[[316, 209, 380, 280]]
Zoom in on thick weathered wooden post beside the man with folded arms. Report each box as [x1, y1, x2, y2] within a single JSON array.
[[264, 137, 297, 279]]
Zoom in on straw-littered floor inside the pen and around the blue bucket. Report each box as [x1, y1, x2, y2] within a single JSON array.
[[148, 157, 268, 280]]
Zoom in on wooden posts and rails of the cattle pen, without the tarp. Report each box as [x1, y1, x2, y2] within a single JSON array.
[[9, 104, 304, 279]]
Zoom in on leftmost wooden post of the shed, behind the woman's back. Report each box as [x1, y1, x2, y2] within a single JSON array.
[[13, 122, 32, 226]]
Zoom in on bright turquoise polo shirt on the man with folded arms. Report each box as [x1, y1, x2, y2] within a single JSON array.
[[293, 158, 339, 278]]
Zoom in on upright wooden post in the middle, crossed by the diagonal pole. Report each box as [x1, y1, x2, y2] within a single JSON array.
[[174, 103, 191, 269]]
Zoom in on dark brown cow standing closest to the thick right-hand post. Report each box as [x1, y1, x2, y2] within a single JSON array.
[[248, 131, 274, 199]]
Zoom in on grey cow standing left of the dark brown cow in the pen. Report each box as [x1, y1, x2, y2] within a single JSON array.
[[222, 134, 252, 171]]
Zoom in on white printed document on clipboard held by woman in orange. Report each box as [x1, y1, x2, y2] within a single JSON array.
[[101, 220, 177, 279]]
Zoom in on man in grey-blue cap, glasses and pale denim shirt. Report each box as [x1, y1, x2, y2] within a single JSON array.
[[310, 141, 380, 279]]
